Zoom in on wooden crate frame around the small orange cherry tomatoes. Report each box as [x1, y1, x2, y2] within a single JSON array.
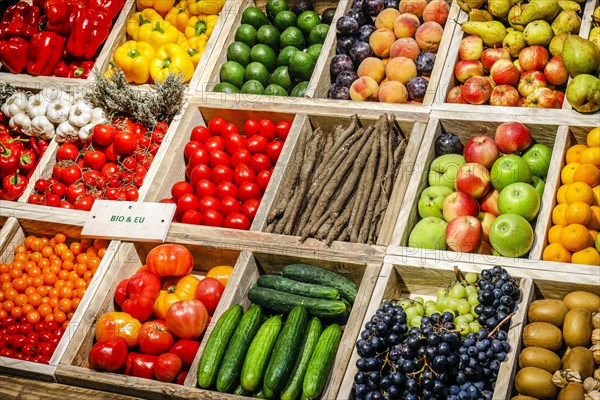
[[0, 218, 120, 381]]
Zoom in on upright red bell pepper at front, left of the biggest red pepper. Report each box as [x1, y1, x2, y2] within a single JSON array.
[[27, 31, 65, 76]]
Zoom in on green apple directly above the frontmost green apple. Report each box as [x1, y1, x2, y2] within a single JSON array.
[[498, 182, 540, 221]]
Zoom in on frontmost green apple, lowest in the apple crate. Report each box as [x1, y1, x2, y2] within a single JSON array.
[[490, 214, 533, 257]]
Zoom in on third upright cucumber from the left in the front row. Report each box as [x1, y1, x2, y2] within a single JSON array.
[[240, 315, 282, 392]]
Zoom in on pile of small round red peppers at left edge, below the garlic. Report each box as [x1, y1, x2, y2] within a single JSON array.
[[0, 124, 48, 201]]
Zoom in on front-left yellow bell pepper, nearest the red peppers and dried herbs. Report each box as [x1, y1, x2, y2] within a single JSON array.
[[114, 40, 154, 84]]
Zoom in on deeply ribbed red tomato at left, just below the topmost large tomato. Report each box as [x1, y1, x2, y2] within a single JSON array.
[[115, 272, 162, 321]]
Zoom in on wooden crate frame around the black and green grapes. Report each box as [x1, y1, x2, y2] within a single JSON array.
[[338, 256, 533, 400]]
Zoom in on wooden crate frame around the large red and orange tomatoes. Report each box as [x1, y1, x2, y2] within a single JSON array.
[[56, 239, 243, 399]]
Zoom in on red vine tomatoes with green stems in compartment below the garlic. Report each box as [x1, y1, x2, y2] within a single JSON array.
[[28, 119, 169, 211]]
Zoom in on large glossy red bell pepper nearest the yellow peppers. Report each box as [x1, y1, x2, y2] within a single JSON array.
[[67, 7, 112, 60]]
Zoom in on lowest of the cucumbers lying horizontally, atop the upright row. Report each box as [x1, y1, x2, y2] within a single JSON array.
[[248, 286, 346, 318]]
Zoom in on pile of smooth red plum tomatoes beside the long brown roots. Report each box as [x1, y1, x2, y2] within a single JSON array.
[[162, 117, 291, 230]]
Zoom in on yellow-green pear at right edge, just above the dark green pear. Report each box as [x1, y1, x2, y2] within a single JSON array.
[[562, 35, 600, 77]]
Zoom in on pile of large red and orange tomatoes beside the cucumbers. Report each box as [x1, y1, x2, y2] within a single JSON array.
[[89, 244, 232, 384]]
